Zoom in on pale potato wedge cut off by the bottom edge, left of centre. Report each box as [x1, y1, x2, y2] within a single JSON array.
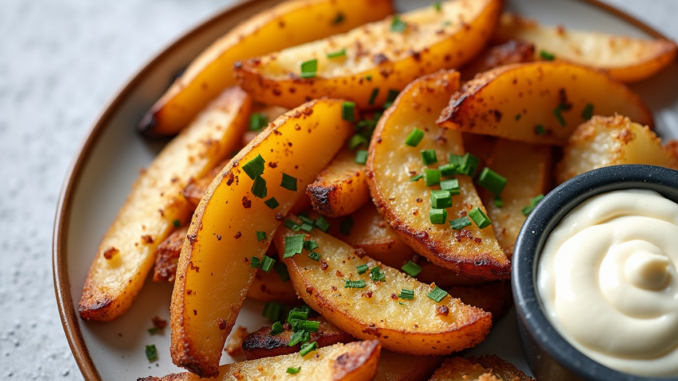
[[140, 340, 381, 381]]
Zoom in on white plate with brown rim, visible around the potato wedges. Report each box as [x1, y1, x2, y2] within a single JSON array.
[[53, 0, 678, 380]]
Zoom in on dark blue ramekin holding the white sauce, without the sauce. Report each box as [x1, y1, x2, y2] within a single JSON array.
[[512, 165, 678, 381]]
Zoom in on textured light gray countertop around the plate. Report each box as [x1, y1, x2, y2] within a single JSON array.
[[0, 0, 678, 380]]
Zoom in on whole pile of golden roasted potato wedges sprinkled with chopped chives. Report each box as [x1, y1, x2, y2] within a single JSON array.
[[79, 0, 678, 381]]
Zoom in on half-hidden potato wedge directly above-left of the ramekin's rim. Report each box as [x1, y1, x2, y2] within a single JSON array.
[[479, 139, 552, 258]]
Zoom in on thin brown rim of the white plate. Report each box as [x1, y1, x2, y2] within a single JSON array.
[[52, 0, 669, 381]]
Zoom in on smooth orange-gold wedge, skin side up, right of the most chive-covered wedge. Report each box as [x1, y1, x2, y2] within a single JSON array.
[[438, 61, 652, 145]]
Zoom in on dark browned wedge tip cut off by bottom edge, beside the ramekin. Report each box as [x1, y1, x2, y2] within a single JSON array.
[[430, 355, 536, 381]]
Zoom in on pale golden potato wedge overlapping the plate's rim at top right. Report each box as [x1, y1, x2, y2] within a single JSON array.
[[494, 14, 676, 83]]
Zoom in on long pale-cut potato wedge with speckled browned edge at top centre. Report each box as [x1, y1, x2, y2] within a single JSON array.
[[235, 0, 503, 109]]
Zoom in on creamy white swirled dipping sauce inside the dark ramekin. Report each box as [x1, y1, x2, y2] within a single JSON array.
[[537, 190, 678, 377]]
